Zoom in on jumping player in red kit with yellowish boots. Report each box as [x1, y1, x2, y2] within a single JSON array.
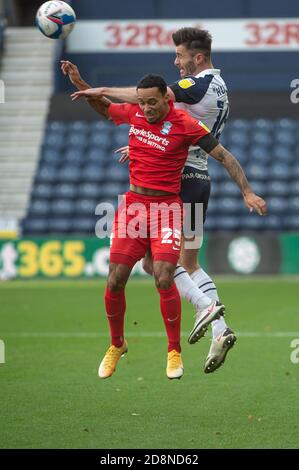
[[72, 75, 266, 379]]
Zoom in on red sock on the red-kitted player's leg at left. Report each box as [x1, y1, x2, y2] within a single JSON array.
[[105, 287, 126, 348]]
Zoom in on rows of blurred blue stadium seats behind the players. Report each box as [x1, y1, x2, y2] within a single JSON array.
[[23, 118, 299, 235]]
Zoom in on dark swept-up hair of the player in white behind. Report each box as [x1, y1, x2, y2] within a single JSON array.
[[172, 28, 212, 59]]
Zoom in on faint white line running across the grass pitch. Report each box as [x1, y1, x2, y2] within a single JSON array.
[[1, 331, 299, 339]]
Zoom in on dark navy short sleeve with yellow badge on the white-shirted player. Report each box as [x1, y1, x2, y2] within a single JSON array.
[[169, 74, 214, 104]]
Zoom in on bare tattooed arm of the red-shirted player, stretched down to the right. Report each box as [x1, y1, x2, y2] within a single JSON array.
[[210, 144, 267, 215]]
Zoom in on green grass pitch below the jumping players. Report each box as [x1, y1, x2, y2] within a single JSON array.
[[0, 278, 299, 449]]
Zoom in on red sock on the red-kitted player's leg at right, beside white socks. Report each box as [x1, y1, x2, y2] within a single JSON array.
[[158, 283, 181, 352]]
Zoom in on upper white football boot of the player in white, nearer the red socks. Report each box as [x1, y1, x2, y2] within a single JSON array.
[[188, 300, 225, 344]]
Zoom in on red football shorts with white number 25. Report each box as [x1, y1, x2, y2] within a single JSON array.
[[110, 191, 183, 266]]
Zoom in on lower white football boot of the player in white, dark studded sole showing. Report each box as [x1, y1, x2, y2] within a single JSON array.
[[204, 328, 237, 374]]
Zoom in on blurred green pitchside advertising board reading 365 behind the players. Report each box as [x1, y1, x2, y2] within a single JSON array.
[[0, 233, 299, 281]]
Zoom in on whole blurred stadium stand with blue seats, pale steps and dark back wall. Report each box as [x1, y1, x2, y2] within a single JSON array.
[[0, 0, 299, 235]]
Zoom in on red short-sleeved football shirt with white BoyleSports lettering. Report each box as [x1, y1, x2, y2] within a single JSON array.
[[108, 102, 209, 194]]
